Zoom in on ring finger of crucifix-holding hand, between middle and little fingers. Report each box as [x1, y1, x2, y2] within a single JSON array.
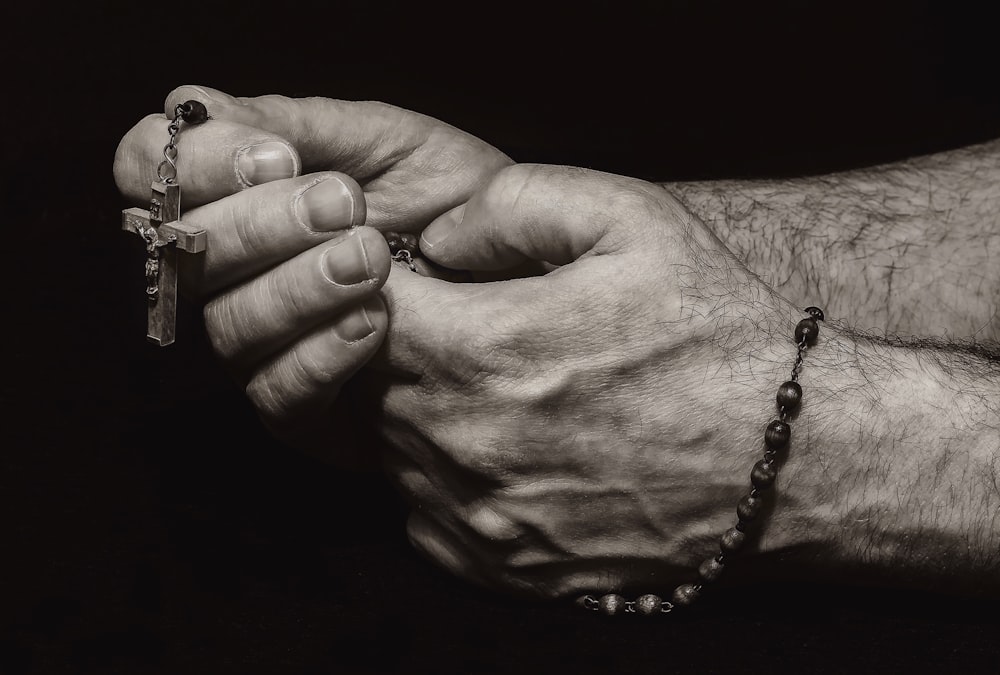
[[205, 227, 390, 369]]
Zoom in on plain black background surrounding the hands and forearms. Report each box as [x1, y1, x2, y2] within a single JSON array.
[[0, 2, 1000, 673]]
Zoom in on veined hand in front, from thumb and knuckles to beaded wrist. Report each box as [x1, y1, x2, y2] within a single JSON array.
[[363, 165, 848, 595]]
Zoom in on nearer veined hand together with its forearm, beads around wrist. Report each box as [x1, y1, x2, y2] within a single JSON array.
[[380, 165, 1000, 596]]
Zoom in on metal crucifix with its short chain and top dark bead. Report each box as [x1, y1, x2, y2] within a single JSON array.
[[122, 101, 208, 347]]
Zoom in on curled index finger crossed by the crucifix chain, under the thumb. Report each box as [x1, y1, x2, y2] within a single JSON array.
[[114, 115, 301, 207]]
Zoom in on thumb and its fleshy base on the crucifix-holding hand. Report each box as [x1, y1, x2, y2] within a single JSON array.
[[166, 86, 511, 232]]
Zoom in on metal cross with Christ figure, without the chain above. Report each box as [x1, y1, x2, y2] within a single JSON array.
[[122, 182, 208, 347]]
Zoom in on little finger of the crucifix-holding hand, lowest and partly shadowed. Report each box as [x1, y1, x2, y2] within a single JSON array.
[[246, 295, 388, 438]]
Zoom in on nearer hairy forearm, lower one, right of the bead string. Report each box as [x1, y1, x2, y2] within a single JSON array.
[[769, 326, 1000, 592]]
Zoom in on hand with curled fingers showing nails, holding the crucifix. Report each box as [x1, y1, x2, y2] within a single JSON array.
[[114, 87, 510, 460]]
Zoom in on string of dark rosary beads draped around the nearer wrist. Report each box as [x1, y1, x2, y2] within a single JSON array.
[[577, 307, 824, 616]]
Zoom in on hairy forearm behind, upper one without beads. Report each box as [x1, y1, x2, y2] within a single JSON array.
[[666, 141, 1000, 341]]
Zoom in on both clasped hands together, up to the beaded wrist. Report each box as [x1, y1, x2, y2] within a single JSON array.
[[114, 86, 820, 597]]
